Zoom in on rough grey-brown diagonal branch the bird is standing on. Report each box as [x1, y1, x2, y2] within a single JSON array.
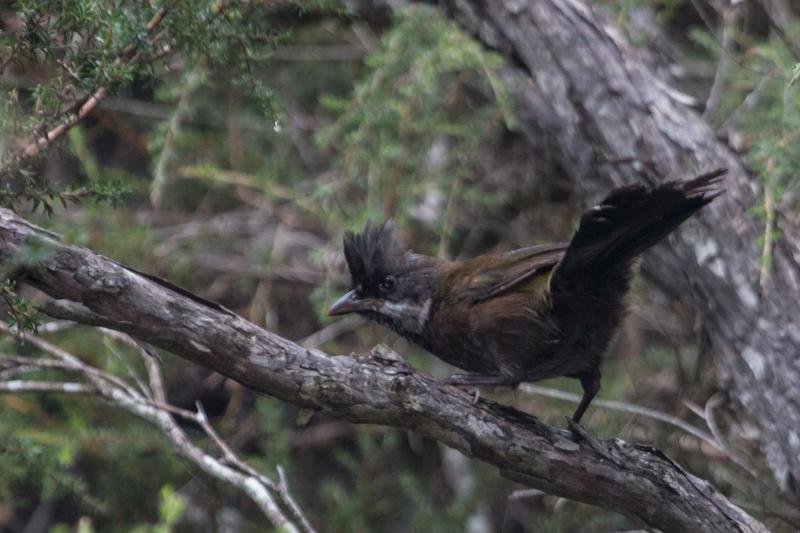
[[0, 209, 766, 531]]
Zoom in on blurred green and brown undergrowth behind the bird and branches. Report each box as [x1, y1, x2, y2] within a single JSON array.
[[0, 0, 800, 533]]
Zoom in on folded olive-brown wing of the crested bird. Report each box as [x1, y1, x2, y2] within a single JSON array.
[[459, 243, 567, 303]]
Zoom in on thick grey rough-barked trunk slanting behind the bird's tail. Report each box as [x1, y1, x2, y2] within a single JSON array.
[[422, 0, 800, 498]]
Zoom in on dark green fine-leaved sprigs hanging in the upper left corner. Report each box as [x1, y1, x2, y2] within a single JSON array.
[[0, 0, 327, 215]]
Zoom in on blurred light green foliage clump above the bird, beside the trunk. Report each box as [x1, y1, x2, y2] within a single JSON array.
[[317, 6, 513, 228]]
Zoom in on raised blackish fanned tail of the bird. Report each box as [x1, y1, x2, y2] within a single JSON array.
[[552, 169, 727, 289]]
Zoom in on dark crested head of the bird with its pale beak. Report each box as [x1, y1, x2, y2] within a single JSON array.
[[328, 222, 438, 339]]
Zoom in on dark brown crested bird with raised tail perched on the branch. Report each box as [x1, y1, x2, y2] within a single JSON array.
[[328, 169, 727, 424]]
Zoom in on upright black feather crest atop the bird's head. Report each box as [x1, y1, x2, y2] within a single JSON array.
[[344, 221, 399, 287]]
